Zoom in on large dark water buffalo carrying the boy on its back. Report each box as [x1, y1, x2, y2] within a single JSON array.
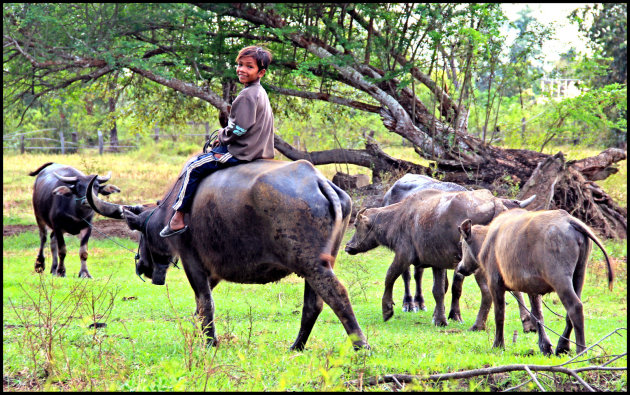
[[88, 159, 368, 350]]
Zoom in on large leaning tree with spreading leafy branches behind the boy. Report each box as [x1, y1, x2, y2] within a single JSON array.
[[3, 3, 628, 238]]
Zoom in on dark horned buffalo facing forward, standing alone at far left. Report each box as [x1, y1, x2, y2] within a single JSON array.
[[29, 162, 120, 278]]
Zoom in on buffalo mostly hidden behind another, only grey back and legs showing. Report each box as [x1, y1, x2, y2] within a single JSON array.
[[383, 173, 467, 312]]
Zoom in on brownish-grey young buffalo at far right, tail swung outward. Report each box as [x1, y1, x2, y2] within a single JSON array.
[[457, 209, 613, 355]]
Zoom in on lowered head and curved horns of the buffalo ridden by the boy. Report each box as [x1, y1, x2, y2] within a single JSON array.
[[87, 176, 173, 285]]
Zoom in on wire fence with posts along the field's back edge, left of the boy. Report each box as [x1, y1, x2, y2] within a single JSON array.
[[2, 122, 216, 155]]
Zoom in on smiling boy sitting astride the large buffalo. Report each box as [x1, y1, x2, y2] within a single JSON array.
[[160, 46, 274, 237]]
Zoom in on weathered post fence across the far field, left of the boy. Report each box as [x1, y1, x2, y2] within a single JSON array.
[[2, 122, 215, 155]]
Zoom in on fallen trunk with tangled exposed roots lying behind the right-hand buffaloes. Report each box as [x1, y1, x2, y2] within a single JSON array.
[[286, 131, 628, 239]]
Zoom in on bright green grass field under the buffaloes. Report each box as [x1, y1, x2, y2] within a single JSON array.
[[3, 151, 627, 391]]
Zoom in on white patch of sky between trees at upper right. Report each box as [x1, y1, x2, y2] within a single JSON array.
[[501, 3, 593, 71]]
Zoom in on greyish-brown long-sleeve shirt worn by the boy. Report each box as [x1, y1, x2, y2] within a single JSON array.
[[219, 81, 274, 161]]
